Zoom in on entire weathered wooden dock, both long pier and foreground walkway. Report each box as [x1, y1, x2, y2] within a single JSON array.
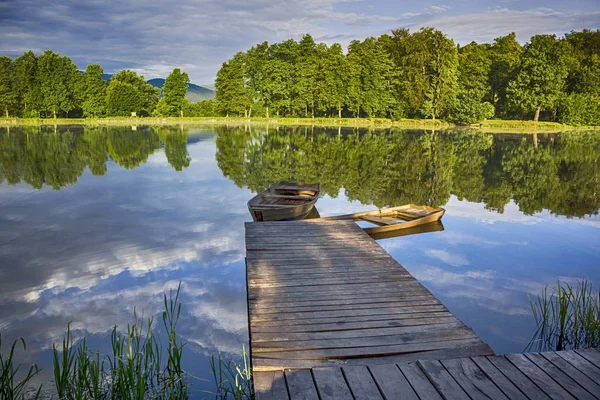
[[246, 221, 600, 400]]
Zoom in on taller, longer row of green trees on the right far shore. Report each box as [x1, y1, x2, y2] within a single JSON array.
[[215, 28, 600, 125]]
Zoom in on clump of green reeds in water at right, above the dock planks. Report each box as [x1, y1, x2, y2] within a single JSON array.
[[527, 280, 600, 351]]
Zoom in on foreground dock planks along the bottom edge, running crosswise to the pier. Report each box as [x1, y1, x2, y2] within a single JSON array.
[[254, 349, 600, 400]]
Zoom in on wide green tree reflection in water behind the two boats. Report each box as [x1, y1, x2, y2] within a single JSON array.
[[216, 127, 600, 217]]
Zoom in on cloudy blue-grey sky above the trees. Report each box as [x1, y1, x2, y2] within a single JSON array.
[[0, 0, 600, 85]]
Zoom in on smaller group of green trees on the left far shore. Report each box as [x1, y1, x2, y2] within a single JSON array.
[[0, 50, 203, 118]]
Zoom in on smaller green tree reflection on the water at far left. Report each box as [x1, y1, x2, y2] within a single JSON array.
[[0, 126, 190, 190]]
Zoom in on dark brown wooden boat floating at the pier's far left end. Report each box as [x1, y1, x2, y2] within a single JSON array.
[[248, 182, 321, 221]]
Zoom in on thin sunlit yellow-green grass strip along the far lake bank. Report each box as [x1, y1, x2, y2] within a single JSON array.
[[0, 117, 600, 133]]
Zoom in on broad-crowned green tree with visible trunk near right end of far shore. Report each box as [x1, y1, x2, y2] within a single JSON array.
[[506, 35, 570, 121]]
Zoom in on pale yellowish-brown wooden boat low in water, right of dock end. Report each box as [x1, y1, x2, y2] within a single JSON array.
[[321, 204, 446, 235]]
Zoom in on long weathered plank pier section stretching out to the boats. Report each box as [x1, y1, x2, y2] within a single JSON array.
[[246, 221, 493, 372]]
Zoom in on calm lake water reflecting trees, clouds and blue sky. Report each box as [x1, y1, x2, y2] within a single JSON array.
[[0, 127, 600, 397]]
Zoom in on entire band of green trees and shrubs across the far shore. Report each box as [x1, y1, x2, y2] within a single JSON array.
[[0, 27, 600, 129]]
